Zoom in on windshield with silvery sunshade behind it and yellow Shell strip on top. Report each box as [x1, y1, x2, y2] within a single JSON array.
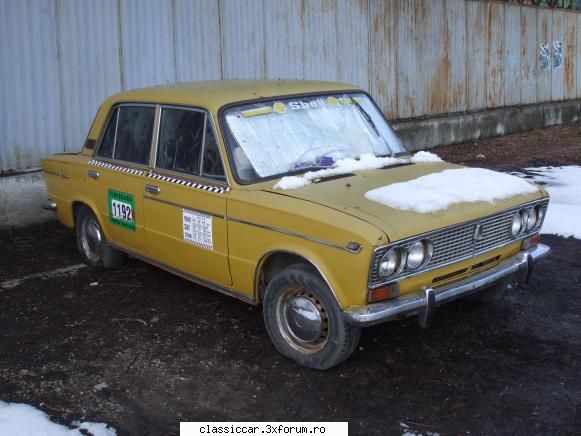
[[224, 93, 407, 182]]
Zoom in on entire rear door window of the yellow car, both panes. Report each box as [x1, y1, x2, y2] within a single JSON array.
[[97, 106, 155, 165]]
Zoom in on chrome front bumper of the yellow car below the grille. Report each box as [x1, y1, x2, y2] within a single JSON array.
[[343, 244, 551, 326]]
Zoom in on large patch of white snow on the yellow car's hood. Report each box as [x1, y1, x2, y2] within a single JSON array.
[[365, 168, 537, 213]]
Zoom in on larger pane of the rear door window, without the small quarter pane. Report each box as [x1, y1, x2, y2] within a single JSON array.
[[113, 106, 155, 165]]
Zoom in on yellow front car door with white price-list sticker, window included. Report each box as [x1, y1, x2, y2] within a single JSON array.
[[143, 106, 231, 285]]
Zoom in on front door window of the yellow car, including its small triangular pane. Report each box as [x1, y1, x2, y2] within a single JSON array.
[[156, 108, 226, 180]]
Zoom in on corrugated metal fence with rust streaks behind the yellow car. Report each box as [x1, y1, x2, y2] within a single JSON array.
[[0, 0, 581, 171]]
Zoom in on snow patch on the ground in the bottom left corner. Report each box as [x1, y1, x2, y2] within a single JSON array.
[[0, 401, 117, 436]]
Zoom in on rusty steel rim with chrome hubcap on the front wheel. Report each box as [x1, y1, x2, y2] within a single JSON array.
[[276, 285, 329, 354]]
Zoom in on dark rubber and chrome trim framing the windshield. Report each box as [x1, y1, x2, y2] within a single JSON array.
[[218, 88, 410, 186]]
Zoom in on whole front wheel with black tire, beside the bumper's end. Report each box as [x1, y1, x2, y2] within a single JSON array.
[[263, 264, 361, 370]]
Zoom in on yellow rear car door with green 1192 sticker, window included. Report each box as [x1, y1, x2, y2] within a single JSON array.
[[87, 104, 156, 254]]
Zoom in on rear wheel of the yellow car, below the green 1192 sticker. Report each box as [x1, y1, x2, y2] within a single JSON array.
[[75, 205, 125, 268]]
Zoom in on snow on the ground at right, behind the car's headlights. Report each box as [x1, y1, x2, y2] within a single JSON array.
[[520, 166, 581, 239]]
